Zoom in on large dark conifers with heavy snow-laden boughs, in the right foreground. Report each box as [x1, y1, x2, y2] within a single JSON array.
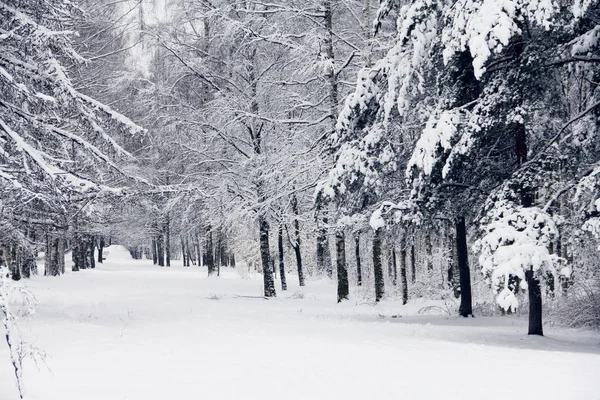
[[319, 0, 600, 335]]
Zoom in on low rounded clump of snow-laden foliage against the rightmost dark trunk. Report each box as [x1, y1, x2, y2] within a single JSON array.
[[474, 202, 570, 311]]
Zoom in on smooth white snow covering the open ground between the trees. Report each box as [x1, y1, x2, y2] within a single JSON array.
[[0, 247, 600, 400]]
